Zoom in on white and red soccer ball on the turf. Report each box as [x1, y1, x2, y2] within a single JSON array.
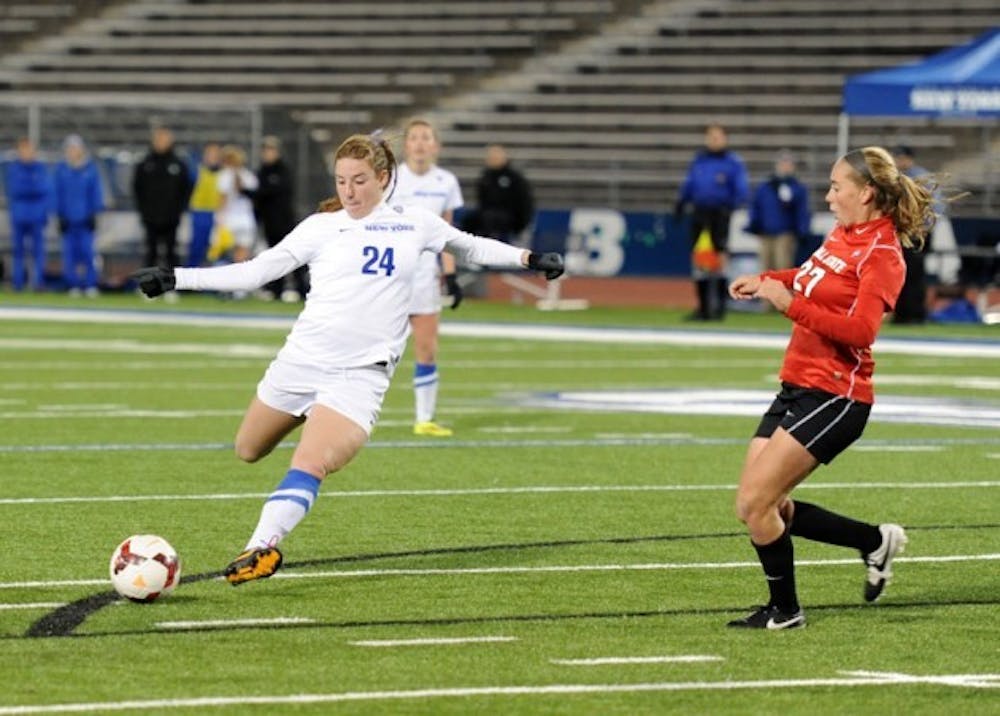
[[110, 535, 181, 602]]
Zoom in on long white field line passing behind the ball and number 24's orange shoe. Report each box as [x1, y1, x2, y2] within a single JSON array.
[[0, 553, 1000, 592]]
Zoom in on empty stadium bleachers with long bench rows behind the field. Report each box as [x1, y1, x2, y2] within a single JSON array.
[[0, 0, 1000, 215]]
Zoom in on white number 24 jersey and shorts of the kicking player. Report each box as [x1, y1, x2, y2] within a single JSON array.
[[175, 203, 524, 432]]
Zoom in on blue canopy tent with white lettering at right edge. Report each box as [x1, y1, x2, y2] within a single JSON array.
[[837, 27, 1000, 155]]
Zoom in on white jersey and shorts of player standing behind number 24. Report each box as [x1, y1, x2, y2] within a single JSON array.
[[390, 163, 463, 315]]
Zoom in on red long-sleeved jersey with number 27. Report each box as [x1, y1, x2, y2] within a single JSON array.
[[761, 217, 906, 404]]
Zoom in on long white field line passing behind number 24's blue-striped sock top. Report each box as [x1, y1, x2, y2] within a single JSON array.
[[0, 480, 1000, 505]]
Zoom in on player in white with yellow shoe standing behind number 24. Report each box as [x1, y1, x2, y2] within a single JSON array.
[[389, 119, 462, 437]]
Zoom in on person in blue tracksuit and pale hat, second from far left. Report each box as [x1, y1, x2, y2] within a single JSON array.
[[55, 134, 104, 297]]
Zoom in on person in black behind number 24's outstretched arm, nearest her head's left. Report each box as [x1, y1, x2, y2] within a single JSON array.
[[253, 136, 309, 303]]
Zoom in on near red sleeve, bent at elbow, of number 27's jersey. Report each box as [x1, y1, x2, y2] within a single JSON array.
[[788, 248, 906, 348]]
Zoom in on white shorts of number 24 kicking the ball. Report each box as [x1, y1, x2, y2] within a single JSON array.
[[257, 360, 392, 435]]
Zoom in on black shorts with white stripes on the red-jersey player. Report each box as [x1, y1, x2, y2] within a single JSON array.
[[754, 383, 872, 464]]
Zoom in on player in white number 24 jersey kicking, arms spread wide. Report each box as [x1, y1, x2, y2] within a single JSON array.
[[133, 134, 563, 585]]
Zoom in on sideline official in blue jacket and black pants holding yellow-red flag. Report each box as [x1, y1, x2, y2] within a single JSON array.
[[674, 124, 750, 321]]
